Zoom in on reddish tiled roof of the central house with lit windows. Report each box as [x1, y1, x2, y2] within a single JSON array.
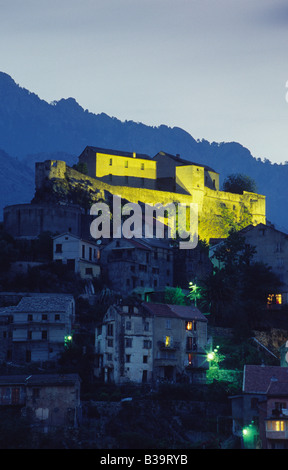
[[142, 302, 207, 322]]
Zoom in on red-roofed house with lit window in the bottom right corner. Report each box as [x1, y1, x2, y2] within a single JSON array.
[[230, 365, 288, 449]]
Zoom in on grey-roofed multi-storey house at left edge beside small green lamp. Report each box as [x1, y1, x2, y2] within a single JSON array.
[[0, 294, 75, 364]]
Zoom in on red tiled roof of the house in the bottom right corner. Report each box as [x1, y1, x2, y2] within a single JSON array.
[[243, 365, 288, 394]]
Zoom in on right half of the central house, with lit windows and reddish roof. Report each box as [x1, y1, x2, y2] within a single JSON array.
[[142, 302, 209, 382]]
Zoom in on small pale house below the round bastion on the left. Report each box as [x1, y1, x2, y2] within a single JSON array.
[[53, 233, 100, 279]]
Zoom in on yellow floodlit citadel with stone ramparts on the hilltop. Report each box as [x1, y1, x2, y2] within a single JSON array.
[[32, 146, 266, 242]]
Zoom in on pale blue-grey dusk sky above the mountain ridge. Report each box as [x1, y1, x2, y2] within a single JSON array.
[[0, 0, 288, 162]]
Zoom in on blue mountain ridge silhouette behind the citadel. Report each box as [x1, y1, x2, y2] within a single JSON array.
[[0, 72, 288, 232]]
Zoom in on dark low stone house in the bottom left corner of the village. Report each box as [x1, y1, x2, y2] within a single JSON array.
[[0, 374, 81, 432]]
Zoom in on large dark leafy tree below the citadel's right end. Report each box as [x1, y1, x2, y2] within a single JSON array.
[[203, 231, 281, 328]]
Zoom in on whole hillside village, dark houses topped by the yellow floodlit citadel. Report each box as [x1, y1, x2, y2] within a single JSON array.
[[0, 146, 288, 449]]
